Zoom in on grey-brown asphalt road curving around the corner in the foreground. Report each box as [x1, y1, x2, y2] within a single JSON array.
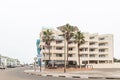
[[0, 67, 117, 80]]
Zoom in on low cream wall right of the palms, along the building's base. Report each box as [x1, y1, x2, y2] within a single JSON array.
[[93, 63, 120, 68]]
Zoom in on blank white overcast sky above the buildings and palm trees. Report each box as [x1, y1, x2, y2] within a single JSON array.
[[0, 0, 120, 63]]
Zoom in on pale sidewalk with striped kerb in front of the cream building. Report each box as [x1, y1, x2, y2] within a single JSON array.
[[24, 69, 120, 79]]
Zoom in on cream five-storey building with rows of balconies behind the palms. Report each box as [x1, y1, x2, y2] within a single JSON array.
[[40, 29, 113, 65]]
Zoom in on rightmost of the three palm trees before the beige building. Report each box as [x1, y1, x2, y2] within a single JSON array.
[[74, 31, 85, 68]]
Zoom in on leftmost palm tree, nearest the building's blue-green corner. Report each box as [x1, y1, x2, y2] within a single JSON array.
[[42, 29, 54, 64]]
